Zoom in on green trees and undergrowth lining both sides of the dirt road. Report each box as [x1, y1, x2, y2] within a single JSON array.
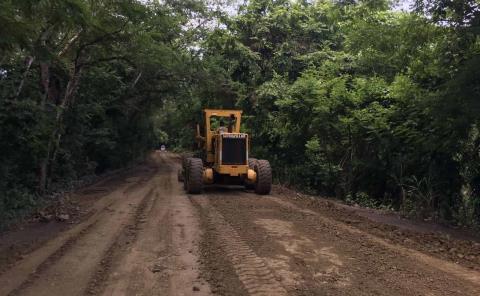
[[0, 0, 480, 225]]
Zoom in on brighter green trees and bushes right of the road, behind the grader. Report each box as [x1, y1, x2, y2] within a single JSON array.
[[171, 0, 480, 224]]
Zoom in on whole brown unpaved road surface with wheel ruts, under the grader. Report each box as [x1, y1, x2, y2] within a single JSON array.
[[0, 152, 480, 296]]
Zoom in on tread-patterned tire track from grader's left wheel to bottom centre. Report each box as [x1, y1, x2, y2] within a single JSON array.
[[190, 196, 288, 296]]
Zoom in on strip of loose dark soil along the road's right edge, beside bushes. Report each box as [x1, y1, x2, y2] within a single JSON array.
[[274, 186, 480, 272]]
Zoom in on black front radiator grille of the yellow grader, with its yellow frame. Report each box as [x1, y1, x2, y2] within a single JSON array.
[[219, 133, 248, 165]]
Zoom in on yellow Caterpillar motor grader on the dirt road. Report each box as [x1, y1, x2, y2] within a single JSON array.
[[178, 109, 272, 194]]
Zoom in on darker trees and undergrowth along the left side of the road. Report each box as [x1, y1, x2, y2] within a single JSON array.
[[0, 0, 209, 221]]
